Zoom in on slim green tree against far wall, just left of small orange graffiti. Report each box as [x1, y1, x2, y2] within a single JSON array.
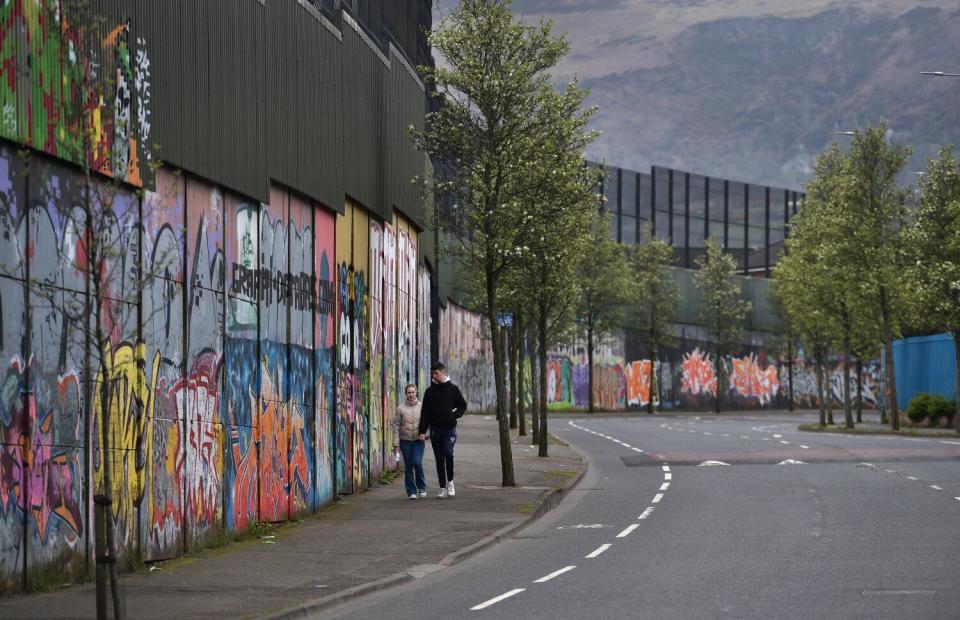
[[577, 214, 632, 413]]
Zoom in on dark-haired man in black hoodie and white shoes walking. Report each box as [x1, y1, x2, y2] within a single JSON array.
[[418, 362, 467, 499]]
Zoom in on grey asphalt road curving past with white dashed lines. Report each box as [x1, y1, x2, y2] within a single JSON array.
[[320, 416, 960, 620]]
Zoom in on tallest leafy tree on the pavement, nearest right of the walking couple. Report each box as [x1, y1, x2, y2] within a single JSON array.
[[413, 0, 569, 486]]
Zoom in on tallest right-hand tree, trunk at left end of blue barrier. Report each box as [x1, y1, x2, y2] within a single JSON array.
[[838, 123, 911, 430]]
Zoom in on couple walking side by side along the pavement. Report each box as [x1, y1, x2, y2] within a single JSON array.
[[393, 362, 467, 499]]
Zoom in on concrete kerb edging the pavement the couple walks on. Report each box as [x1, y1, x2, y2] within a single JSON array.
[[259, 434, 589, 620]]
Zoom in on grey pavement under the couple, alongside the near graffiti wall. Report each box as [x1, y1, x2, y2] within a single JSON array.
[[0, 416, 586, 620]]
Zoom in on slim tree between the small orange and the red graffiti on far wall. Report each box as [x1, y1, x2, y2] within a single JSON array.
[[632, 225, 680, 413]]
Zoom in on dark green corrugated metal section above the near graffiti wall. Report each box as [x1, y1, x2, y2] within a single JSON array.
[[100, 0, 425, 228]]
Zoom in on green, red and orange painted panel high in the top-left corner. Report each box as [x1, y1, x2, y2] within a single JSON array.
[[0, 0, 153, 186]]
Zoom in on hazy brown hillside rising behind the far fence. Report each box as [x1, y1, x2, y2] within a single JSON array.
[[515, 0, 960, 187]]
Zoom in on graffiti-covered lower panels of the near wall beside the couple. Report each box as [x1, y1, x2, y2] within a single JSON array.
[[0, 144, 429, 591]]
